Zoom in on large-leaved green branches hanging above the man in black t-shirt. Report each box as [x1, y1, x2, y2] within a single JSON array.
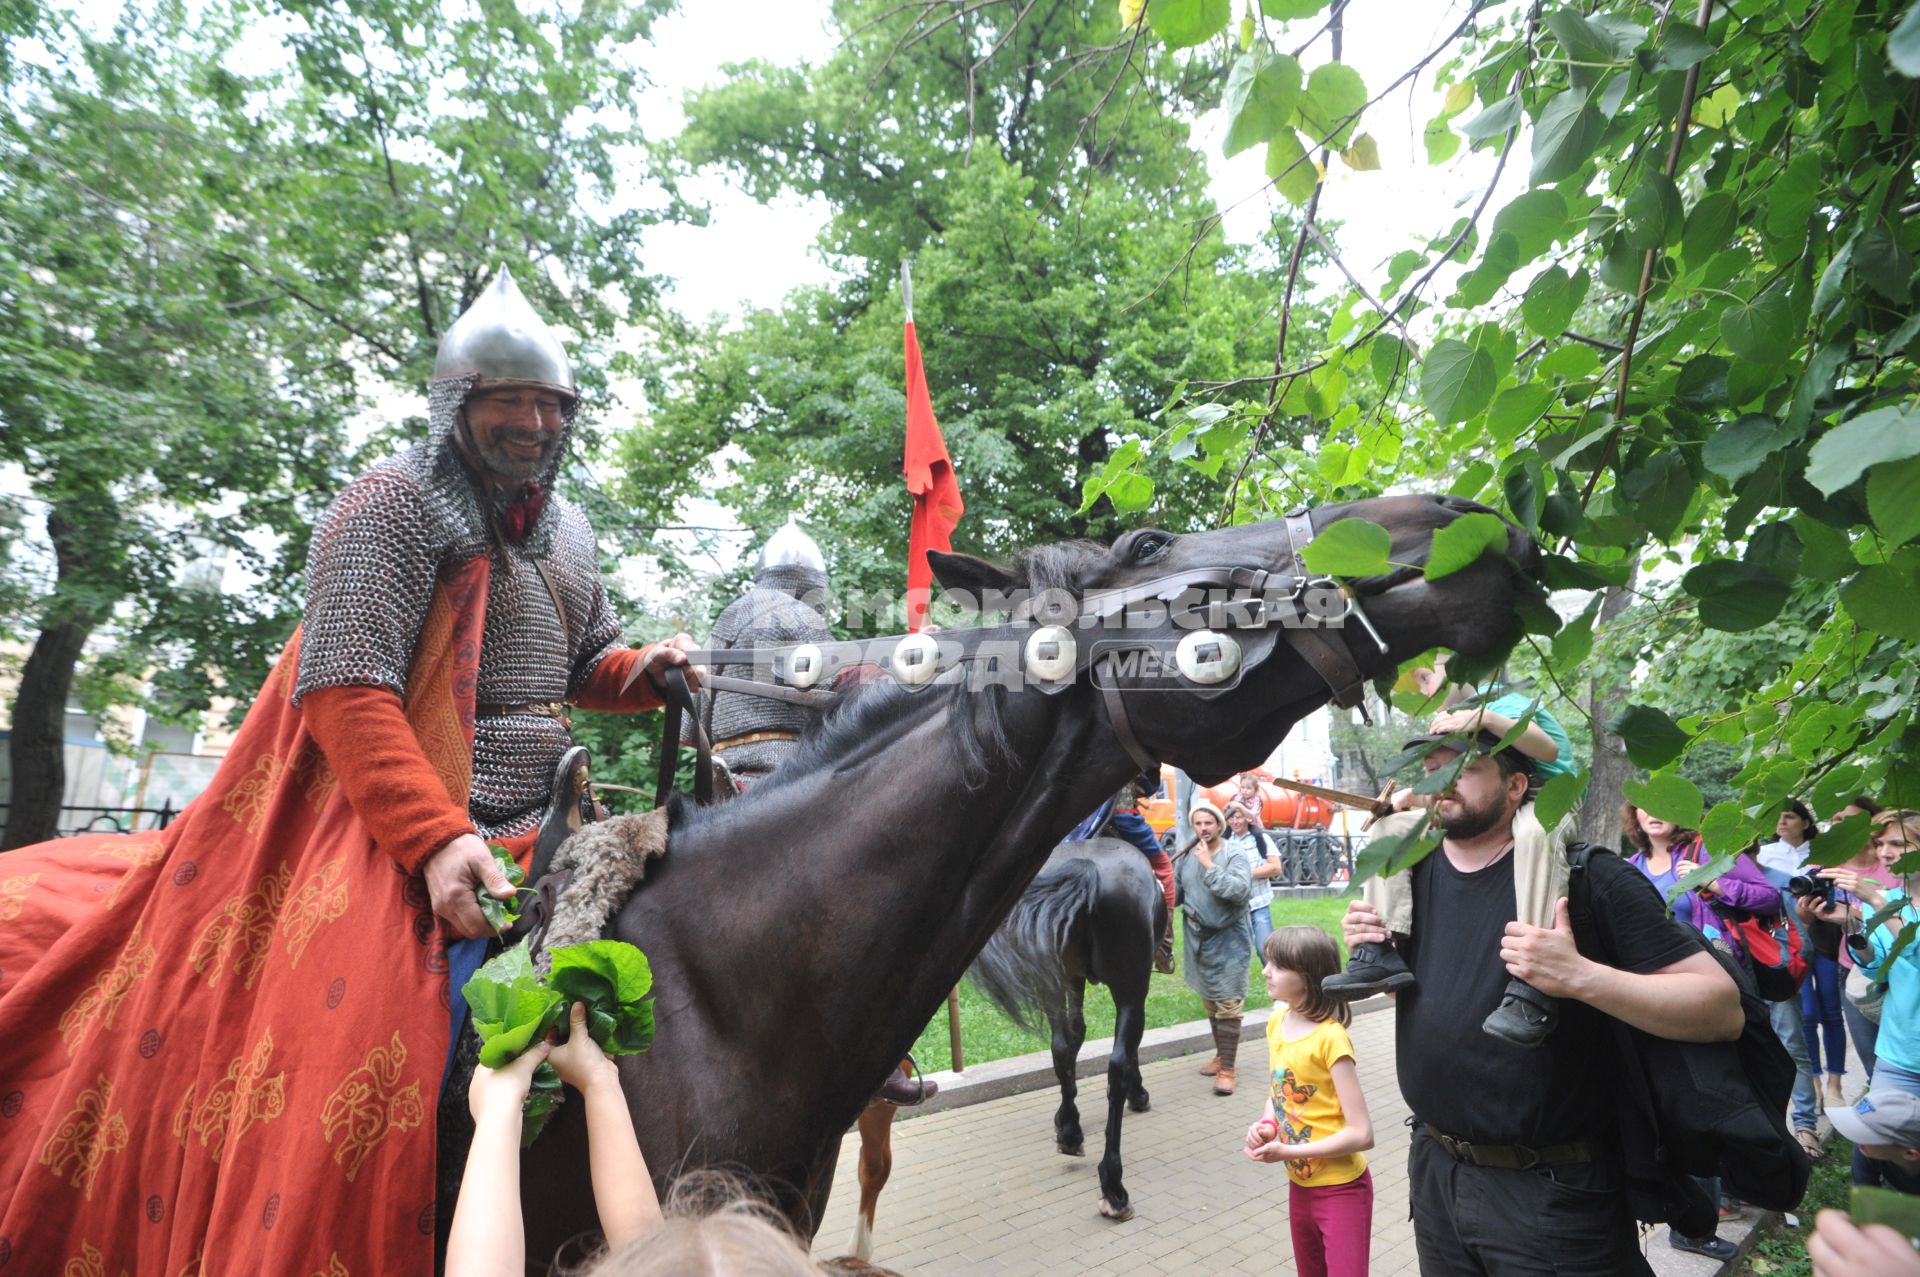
[[1082, 0, 1920, 855]]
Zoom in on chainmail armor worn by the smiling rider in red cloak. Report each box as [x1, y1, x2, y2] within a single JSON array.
[[294, 368, 620, 837]]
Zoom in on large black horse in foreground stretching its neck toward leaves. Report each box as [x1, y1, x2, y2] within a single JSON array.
[[518, 495, 1540, 1265]]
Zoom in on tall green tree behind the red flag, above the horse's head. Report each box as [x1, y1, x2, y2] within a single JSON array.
[[624, 0, 1325, 614]]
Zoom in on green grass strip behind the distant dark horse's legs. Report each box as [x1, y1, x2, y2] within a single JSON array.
[[914, 895, 1352, 1073]]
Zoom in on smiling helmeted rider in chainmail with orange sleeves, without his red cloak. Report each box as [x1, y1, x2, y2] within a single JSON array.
[[294, 271, 693, 937]]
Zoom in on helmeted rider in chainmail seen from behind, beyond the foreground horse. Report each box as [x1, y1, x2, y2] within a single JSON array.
[[701, 518, 833, 789]]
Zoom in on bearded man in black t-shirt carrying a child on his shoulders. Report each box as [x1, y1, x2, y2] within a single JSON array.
[[1342, 737, 1743, 1277]]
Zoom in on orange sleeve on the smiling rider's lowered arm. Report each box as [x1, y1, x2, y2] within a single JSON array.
[[300, 675, 474, 874]]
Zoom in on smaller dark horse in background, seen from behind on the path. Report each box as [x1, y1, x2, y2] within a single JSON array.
[[972, 837, 1167, 1219]]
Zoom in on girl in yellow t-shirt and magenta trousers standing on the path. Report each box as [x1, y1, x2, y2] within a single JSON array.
[[1246, 928, 1373, 1277]]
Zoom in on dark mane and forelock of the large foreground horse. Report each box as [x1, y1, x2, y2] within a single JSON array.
[[672, 542, 1106, 830]]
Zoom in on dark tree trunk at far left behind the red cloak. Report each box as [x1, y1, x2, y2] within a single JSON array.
[[0, 497, 115, 851]]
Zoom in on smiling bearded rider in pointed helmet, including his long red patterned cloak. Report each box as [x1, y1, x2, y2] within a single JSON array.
[[0, 263, 697, 1277]]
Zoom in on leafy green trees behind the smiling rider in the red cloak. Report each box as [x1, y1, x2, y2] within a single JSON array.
[[0, 0, 678, 845]]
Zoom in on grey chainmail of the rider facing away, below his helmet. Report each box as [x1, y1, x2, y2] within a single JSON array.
[[701, 563, 833, 782]]
